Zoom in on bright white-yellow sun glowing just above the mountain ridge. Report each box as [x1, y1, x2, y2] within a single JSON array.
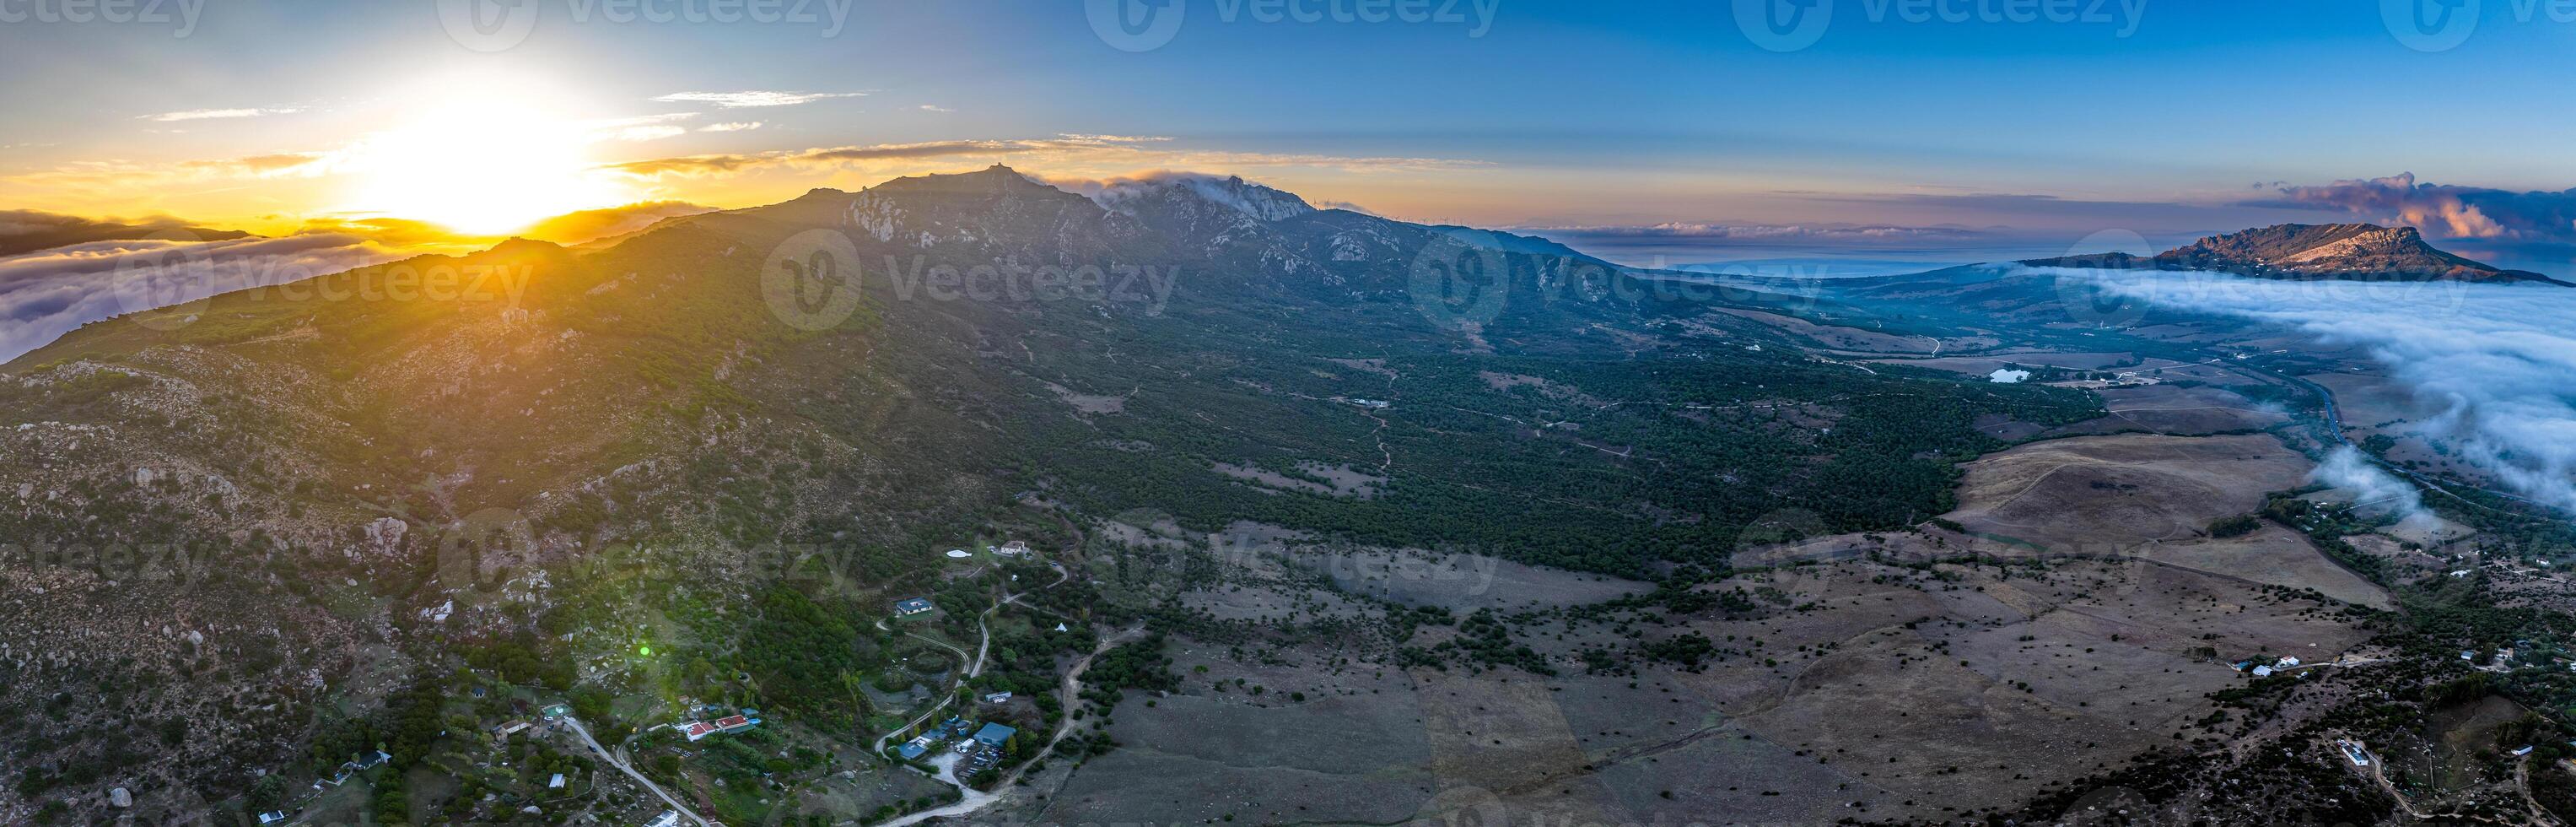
[[350, 88, 633, 235]]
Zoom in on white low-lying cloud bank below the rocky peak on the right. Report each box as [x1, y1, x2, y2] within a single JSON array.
[[2058, 271, 2576, 510]]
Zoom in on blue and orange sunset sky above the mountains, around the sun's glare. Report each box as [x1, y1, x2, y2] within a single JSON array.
[[0, 0, 2576, 262]]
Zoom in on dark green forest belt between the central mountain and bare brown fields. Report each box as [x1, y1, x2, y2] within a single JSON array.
[[1005, 339, 2099, 577]]
